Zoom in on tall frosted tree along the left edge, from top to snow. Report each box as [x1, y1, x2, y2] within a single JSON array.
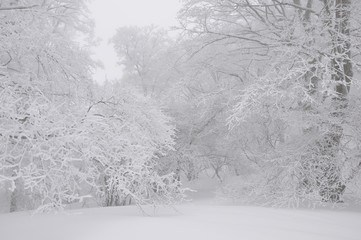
[[0, 0, 92, 211]]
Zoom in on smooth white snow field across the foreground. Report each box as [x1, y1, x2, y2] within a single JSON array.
[[0, 204, 361, 240]]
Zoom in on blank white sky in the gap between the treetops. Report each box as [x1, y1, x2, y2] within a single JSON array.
[[89, 0, 180, 83]]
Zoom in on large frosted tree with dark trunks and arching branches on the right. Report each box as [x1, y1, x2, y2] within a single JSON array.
[[180, 0, 360, 202]]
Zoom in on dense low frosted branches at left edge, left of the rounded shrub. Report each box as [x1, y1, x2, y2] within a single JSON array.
[[0, 79, 92, 210]]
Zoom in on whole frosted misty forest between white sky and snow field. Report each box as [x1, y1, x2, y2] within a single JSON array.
[[0, 0, 361, 212]]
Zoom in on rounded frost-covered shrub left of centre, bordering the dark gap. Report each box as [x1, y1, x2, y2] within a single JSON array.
[[83, 91, 184, 205]]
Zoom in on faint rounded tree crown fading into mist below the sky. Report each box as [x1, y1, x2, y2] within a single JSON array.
[[111, 25, 176, 98]]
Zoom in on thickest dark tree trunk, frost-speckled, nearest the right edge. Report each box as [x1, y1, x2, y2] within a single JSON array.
[[317, 0, 353, 202]]
